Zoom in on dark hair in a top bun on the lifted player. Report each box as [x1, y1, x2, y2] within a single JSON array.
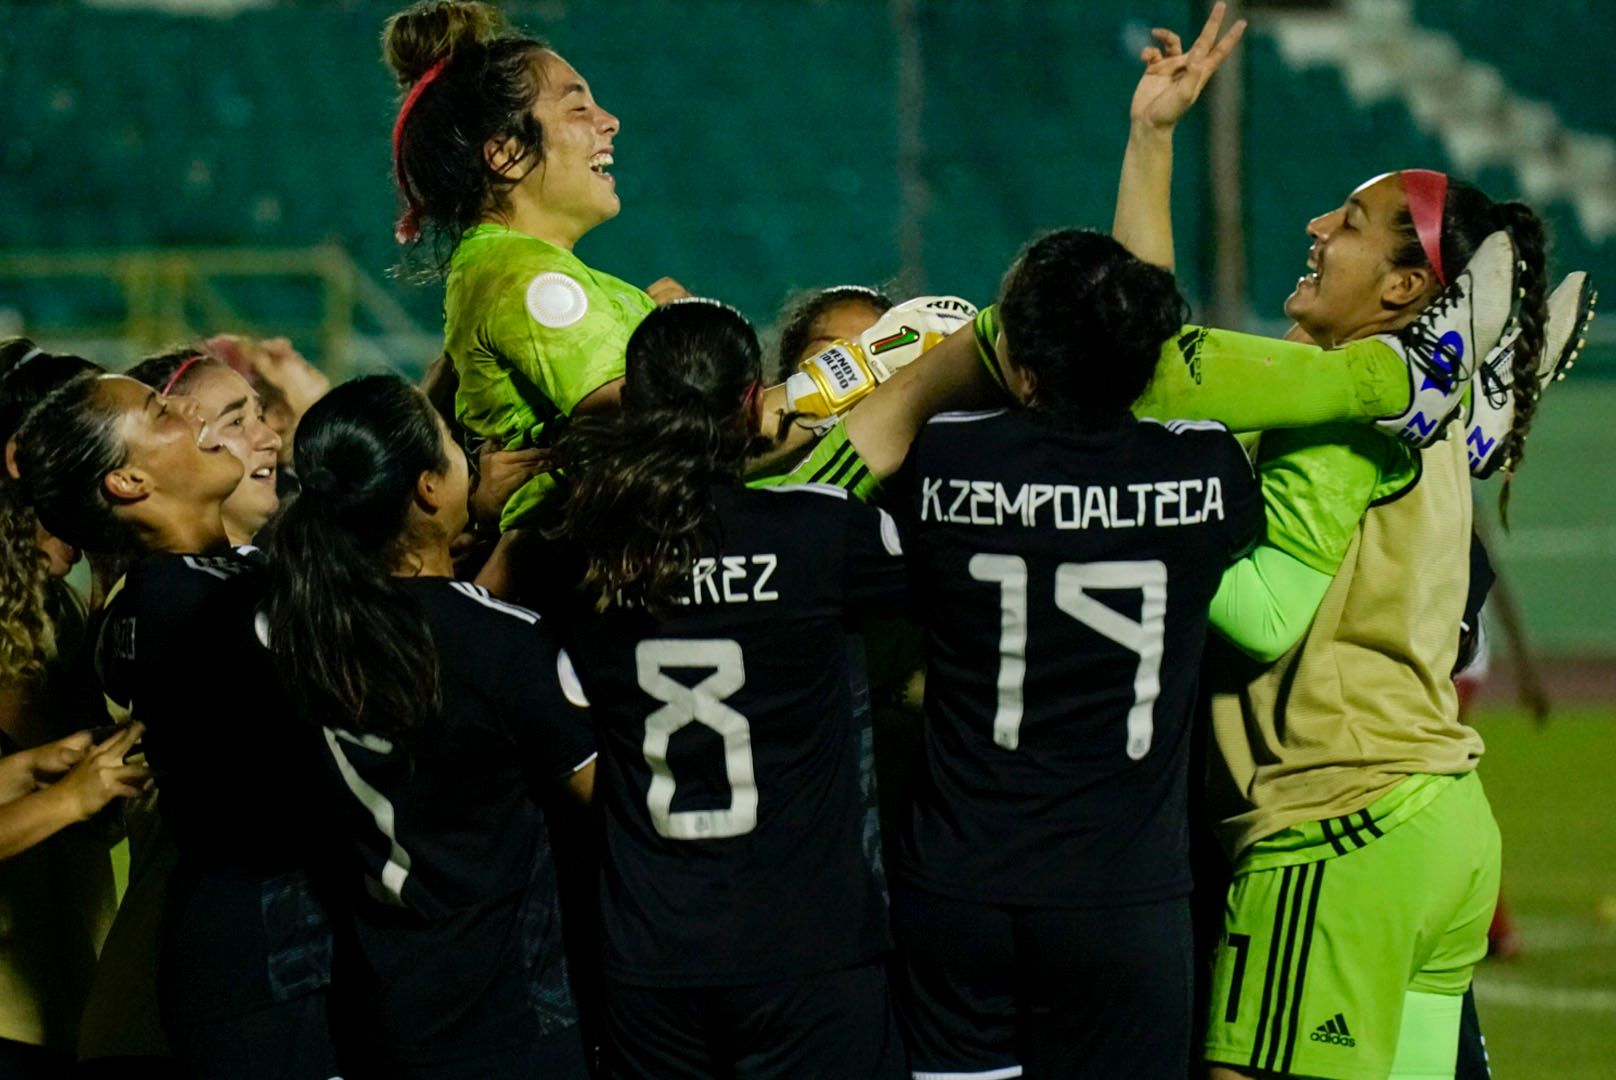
[[381, 0, 549, 272]]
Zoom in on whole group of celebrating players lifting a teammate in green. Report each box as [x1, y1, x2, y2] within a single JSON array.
[[0, 0, 1592, 1080]]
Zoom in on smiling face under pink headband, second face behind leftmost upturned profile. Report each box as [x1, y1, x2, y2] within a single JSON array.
[[181, 364, 281, 543]]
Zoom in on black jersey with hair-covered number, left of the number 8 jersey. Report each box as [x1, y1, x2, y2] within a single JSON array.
[[303, 577, 595, 1064]]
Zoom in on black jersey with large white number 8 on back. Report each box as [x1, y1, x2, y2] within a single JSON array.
[[564, 485, 905, 986]]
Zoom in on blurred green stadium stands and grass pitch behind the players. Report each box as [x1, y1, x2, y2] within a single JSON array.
[[0, 0, 1616, 1080]]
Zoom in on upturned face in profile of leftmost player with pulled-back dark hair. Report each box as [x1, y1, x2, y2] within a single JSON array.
[[95, 375, 244, 506]]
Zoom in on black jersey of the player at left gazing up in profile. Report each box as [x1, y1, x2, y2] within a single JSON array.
[[95, 548, 330, 1020]]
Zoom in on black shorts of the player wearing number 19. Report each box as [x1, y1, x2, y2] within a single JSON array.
[[892, 886, 1193, 1080]]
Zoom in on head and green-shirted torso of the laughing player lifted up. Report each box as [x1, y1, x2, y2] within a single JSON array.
[[385, 0, 669, 525]]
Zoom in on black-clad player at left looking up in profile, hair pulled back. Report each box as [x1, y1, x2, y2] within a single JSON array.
[[16, 375, 335, 1080]]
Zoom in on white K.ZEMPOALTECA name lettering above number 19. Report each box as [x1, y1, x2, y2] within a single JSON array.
[[920, 477, 1223, 529]]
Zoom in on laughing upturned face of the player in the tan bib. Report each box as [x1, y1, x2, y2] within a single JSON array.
[[1285, 173, 1437, 348]]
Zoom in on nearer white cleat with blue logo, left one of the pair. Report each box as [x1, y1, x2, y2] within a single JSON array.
[[1377, 230, 1517, 446]]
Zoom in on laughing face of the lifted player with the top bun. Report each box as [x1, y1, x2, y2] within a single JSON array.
[[522, 52, 622, 247]]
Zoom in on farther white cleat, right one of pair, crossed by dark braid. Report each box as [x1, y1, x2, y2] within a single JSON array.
[[1464, 270, 1600, 479]]
